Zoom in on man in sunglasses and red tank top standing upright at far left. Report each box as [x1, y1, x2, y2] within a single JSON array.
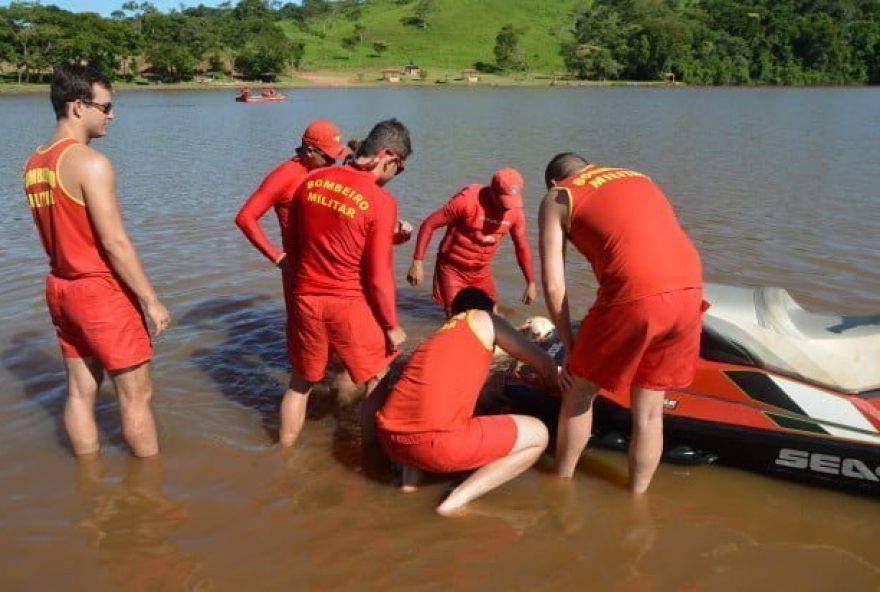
[[24, 64, 171, 457]]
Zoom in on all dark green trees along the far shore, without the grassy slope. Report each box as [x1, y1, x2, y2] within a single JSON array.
[[0, 0, 880, 84]]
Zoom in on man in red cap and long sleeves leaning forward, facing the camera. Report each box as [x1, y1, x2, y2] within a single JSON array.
[[407, 168, 536, 315]]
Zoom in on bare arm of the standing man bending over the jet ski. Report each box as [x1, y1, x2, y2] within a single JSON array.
[[538, 189, 574, 352]]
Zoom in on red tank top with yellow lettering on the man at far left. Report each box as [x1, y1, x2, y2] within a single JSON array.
[[24, 138, 112, 278]]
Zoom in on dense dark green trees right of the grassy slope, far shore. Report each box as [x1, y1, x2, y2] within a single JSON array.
[[562, 0, 880, 84]]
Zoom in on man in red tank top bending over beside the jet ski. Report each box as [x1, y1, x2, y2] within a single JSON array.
[[539, 152, 703, 494]]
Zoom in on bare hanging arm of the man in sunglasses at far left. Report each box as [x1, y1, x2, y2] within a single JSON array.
[[76, 151, 171, 336]]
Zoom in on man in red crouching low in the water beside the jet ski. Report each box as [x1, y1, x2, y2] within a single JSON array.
[[376, 287, 557, 516]]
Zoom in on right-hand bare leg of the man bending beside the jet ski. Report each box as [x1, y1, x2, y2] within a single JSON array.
[[629, 386, 665, 494]]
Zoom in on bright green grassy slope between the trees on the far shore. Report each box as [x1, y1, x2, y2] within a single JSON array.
[[282, 0, 584, 77]]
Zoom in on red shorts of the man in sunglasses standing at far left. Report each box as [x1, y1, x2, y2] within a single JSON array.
[[46, 274, 153, 371]]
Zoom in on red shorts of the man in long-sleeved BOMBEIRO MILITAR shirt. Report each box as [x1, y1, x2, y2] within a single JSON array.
[[287, 295, 399, 383]]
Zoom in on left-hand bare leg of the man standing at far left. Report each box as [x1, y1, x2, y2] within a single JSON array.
[[64, 358, 104, 456]]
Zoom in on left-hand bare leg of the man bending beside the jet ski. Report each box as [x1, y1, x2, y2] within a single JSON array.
[[556, 377, 599, 479]]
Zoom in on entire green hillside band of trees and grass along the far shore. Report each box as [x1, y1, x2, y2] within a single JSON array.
[[0, 0, 880, 84]]
